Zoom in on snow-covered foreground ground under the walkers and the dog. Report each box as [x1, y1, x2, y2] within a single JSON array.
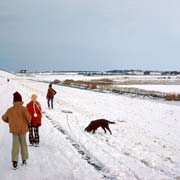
[[0, 71, 180, 180]]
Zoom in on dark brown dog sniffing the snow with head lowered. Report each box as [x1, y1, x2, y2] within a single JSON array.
[[84, 119, 115, 134]]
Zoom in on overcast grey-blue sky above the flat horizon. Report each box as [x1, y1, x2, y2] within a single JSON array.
[[0, 0, 180, 71]]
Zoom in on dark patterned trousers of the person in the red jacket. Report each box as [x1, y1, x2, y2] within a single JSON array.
[[29, 125, 39, 144]]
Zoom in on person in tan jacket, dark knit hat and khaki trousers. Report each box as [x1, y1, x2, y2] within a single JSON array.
[[2, 92, 31, 169]]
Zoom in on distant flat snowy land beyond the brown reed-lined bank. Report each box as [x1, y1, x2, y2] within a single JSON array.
[[17, 73, 180, 94]]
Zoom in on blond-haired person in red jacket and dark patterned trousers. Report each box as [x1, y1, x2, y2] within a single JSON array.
[[26, 94, 42, 147]]
